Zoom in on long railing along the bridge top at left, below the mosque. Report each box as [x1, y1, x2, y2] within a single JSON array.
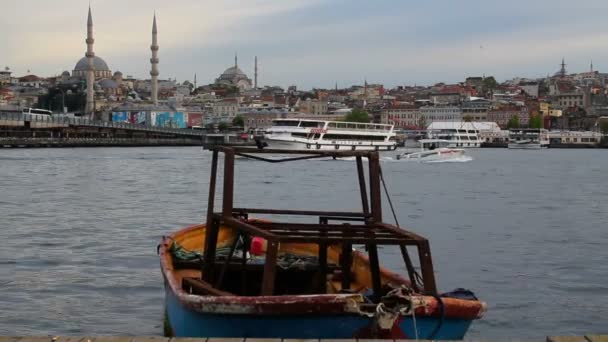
[[0, 112, 205, 136]]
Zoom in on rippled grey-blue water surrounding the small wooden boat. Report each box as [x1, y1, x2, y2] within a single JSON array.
[[0, 147, 608, 338]]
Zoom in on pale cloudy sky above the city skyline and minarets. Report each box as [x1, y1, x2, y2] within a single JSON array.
[[0, 0, 608, 89]]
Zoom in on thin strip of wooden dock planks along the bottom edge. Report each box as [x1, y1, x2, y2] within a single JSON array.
[[0, 335, 608, 342]]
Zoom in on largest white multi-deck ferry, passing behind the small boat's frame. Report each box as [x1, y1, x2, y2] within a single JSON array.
[[264, 119, 397, 151]]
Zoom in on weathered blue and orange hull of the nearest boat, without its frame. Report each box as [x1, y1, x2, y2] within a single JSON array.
[[159, 225, 485, 340]]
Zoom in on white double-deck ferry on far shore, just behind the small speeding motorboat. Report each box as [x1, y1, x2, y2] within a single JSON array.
[[427, 121, 496, 147]]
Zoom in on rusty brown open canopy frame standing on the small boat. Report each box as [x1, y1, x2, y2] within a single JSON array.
[[201, 146, 437, 300]]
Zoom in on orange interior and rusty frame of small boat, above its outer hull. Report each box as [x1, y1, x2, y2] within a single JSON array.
[[163, 146, 437, 303]]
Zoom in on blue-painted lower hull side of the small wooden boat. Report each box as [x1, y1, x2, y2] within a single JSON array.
[[165, 284, 471, 340]]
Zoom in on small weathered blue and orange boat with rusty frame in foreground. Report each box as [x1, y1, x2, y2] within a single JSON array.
[[159, 147, 485, 340]]
